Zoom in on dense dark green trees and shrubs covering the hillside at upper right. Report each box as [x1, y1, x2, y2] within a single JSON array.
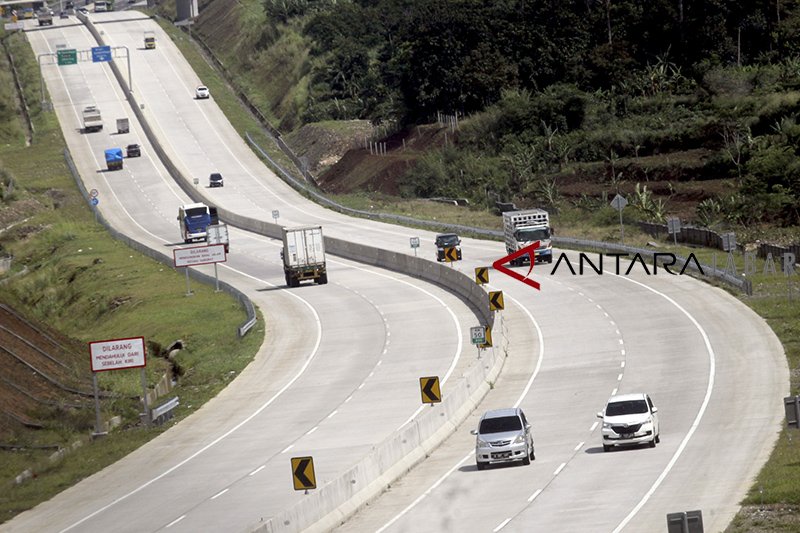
[[222, 0, 800, 226]]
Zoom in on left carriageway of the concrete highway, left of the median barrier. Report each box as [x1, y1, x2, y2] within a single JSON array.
[[7, 17, 488, 531]]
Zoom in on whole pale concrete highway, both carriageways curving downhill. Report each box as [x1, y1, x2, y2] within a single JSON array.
[[6, 12, 788, 532]]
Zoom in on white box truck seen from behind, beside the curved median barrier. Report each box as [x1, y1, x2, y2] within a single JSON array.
[[281, 226, 328, 287]]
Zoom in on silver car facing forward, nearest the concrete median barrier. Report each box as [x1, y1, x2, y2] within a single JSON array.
[[472, 407, 536, 470]]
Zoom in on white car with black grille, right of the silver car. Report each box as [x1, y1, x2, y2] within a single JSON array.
[[597, 392, 661, 452]]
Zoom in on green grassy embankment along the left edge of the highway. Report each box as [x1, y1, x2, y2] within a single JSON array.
[[0, 26, 264, 522]]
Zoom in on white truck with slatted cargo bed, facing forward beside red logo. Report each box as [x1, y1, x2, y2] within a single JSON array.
[[503, 209, 553, 265]]
